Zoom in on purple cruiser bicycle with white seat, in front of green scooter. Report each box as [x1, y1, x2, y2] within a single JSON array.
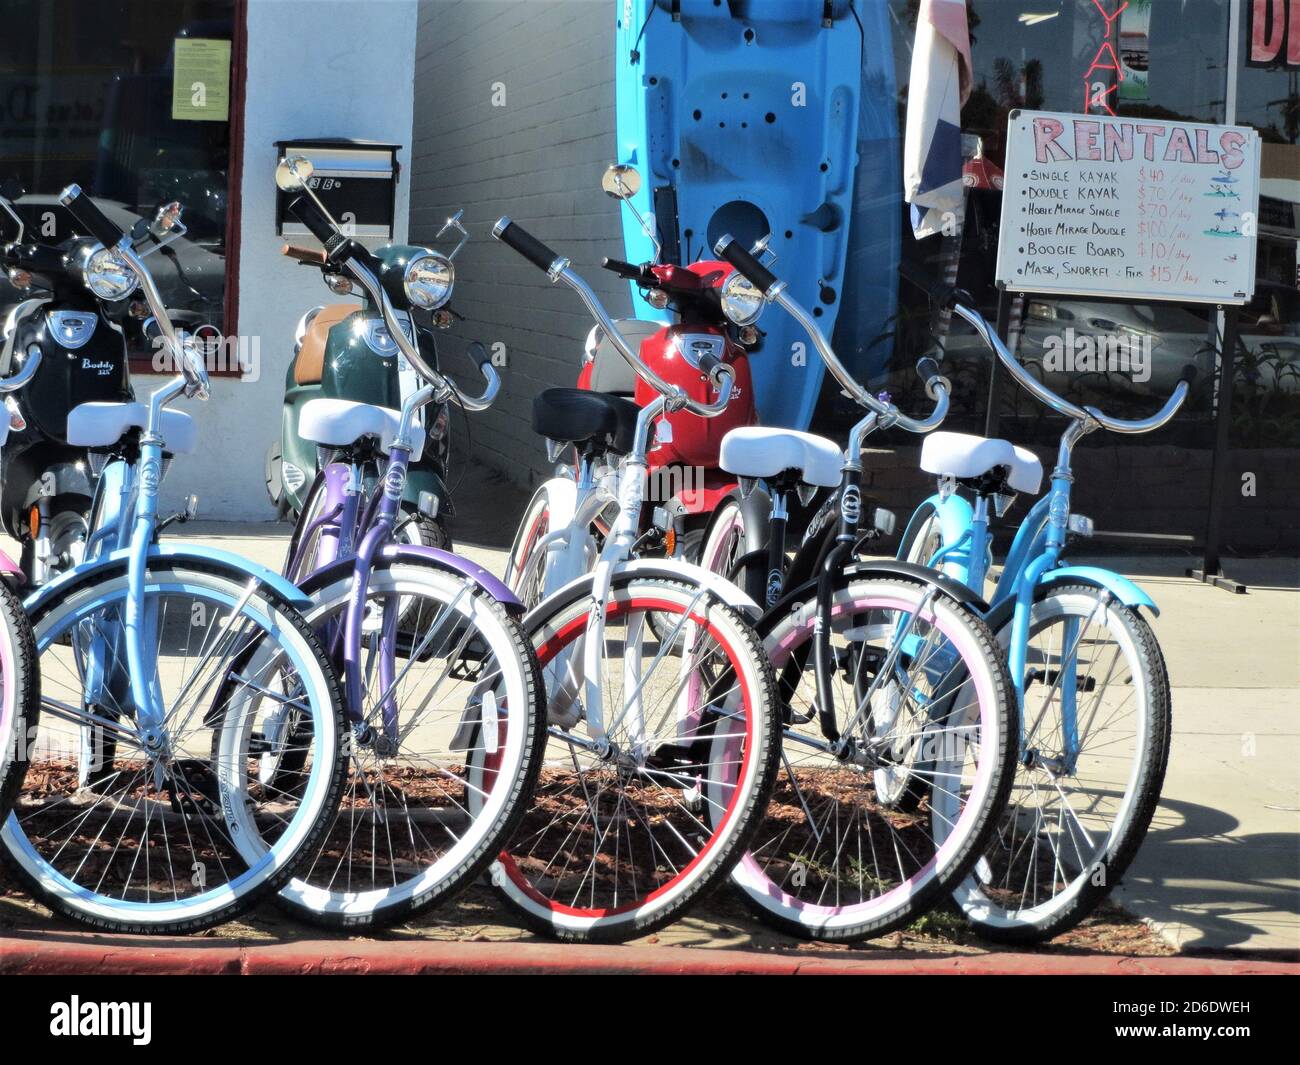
[[260, 156, 545, 927]]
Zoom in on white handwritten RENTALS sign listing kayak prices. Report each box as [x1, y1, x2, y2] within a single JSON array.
[[997, 111, 1260, 303]]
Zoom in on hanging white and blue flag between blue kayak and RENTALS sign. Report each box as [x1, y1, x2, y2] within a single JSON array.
[[902, 0, 971, 238]]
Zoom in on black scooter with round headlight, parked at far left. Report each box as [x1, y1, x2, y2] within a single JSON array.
[[0, 182, 185, 585]]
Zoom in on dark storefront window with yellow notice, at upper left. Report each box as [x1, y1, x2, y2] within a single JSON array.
[[0, 0, 235, 369]]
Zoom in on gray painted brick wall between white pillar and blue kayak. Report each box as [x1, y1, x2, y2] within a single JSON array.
[[408, 0, 631, 482]]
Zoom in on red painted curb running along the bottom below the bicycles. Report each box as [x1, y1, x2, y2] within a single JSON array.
[[0, 931, 1300, 977]]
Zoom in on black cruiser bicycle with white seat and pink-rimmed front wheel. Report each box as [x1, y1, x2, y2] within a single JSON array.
[[703, 237, 1015, 940]]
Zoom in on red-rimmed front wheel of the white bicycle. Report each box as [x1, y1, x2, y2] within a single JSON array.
[[493, 575, 777, 941]]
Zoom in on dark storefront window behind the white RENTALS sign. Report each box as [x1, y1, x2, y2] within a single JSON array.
[[857, 0, 1300, 446]]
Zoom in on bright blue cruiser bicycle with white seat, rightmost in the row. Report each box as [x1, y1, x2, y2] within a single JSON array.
[[898, 263, 1196, 943]]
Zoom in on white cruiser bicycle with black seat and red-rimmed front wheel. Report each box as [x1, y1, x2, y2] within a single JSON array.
[[493, 218, 779, 940]]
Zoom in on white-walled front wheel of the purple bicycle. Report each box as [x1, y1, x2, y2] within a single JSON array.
[[276, 562, 546, 927]]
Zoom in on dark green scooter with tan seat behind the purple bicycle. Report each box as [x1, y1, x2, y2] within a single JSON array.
[[267, 212, 468, 547]]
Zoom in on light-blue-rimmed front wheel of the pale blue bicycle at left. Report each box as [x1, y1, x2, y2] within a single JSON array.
[[0, 558, 345, 932]]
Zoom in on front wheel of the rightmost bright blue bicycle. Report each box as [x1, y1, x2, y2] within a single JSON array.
[[956, 585, 1173, 943]]
